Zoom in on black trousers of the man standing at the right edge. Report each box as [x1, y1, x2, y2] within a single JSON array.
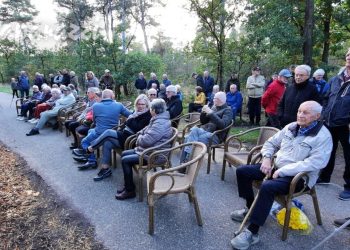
[[320, 125, 350, 190]]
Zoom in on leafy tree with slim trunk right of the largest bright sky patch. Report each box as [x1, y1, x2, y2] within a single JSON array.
[[189, 0, 241, 88]]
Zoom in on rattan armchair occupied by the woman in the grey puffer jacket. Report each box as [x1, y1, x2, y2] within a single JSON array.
[[130, 128, 177, 201]]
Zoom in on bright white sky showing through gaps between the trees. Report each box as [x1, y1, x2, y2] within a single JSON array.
[[32, 0, 197, 49]]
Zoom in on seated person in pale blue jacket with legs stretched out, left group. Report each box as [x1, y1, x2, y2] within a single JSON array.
[[26, 85, 75, 136]]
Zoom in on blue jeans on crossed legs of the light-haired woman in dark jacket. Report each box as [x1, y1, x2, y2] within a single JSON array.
[[90, 129, 120, 165]]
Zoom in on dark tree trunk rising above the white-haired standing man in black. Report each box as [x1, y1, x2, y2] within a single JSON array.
[[303, 0, 314, 66]]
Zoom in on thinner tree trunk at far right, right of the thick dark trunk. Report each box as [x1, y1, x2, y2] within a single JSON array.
[[322, 0, 333, 64]]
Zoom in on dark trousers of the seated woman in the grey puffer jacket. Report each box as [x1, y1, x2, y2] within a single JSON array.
[[121, 149, 142, 192]]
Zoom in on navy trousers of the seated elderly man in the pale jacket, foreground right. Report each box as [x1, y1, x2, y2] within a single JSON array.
[[236, 164, 304, 226]]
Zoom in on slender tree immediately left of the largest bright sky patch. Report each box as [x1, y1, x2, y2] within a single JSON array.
[[128, 0, 164, 53]]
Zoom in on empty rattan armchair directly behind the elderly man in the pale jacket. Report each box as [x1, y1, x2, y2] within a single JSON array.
[[221, 127, 279, 180]]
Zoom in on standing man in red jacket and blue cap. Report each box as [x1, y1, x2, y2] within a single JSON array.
[[261, 69, 292, 128]]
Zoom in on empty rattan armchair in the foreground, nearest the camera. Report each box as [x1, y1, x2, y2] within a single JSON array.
[[147, 142, 207, 235]]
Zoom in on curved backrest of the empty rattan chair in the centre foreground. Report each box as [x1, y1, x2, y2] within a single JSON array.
[[186, 142, 207, 185]]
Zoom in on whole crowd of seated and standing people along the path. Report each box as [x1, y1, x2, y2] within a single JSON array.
[[11, 50, 350, 246]]
